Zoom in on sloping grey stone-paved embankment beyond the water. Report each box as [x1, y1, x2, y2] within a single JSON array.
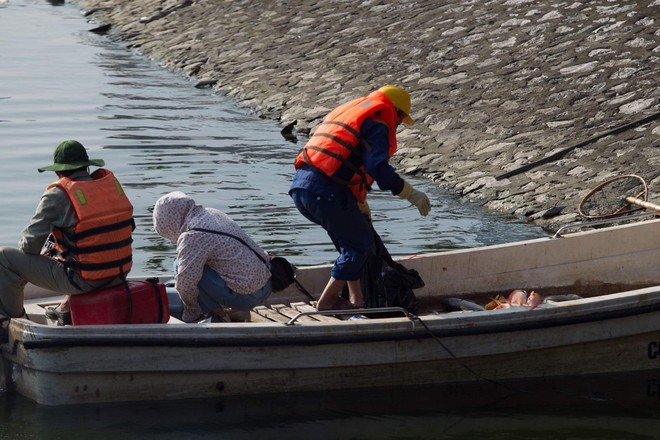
[[77, 0, 660, 229]]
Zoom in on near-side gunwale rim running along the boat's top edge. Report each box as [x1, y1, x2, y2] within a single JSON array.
[[12, 286, 660, 350]]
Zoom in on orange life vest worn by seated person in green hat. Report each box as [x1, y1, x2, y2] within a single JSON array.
[[48, 168, 135, 281]]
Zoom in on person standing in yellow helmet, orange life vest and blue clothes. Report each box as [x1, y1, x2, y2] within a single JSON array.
[[289, 85, 431, 310]]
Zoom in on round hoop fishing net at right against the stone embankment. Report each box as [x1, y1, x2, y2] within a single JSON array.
[[578, 174, 648, 219]]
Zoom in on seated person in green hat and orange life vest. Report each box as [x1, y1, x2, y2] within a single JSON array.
[[0, 140, 135, 340]]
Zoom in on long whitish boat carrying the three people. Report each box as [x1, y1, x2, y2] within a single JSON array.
[[2, 214, 660, 405]]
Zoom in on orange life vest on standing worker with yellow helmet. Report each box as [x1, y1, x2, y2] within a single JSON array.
[[295, 91, 397, 202]]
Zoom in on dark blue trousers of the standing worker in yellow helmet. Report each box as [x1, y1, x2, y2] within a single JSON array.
[[289, 188, 374, 281]]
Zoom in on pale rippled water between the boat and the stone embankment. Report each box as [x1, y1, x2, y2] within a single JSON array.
[[0, 0, 545, 274]]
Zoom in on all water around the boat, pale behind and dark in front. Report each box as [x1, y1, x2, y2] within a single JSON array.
[[0, 0, 660, 440]]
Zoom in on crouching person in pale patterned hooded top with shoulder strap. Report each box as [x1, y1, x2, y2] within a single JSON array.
[[153, 191, 272, 322]]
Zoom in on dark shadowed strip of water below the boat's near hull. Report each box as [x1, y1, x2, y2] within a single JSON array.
[[0, 370, 660, 440]]
